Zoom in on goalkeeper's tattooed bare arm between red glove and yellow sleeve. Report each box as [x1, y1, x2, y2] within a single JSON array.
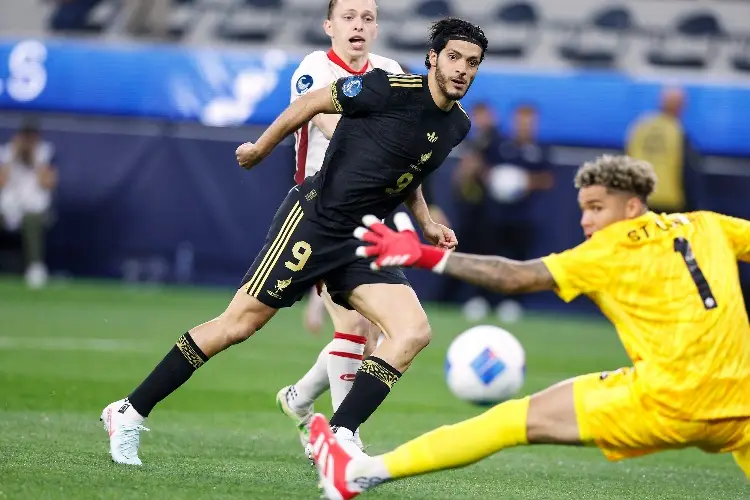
[[444, 253, 555, 293]]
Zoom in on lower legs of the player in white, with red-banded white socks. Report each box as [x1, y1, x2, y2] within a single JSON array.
[[276, 289, 379, 458]]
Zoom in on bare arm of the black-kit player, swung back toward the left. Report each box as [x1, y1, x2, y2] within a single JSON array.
[[236, 88, 339, 168]]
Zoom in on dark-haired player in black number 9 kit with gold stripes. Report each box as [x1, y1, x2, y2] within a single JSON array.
[[101, 18, 487, 465]]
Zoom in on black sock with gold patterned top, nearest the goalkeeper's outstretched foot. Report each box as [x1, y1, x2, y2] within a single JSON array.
[[331, 356, 401, 432]]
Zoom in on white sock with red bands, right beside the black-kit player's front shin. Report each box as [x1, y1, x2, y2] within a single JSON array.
[[328, 332, 367, 412]]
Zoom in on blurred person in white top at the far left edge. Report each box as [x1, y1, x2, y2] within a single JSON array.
[[0, 125, 57, 288]]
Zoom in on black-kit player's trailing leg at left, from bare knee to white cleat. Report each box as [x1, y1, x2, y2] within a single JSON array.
[[100, 289, 276, 465]]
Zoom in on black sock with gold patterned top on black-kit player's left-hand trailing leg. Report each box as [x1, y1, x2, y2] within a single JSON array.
[[128, 332, 208, 417]]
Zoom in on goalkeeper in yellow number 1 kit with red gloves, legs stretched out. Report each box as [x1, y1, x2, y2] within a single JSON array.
[[311, 156, 750, 499]]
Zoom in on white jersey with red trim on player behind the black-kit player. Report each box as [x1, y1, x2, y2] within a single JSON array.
[[291, 50, 404, 184]]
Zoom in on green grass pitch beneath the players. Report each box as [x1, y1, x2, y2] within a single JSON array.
[[0, 280, 750, 500]]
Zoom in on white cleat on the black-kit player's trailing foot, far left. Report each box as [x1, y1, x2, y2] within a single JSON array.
[[99, 399, 148, 465]]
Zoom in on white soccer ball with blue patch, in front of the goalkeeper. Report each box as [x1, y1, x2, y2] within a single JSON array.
[[445, 325, 526, 405]]
